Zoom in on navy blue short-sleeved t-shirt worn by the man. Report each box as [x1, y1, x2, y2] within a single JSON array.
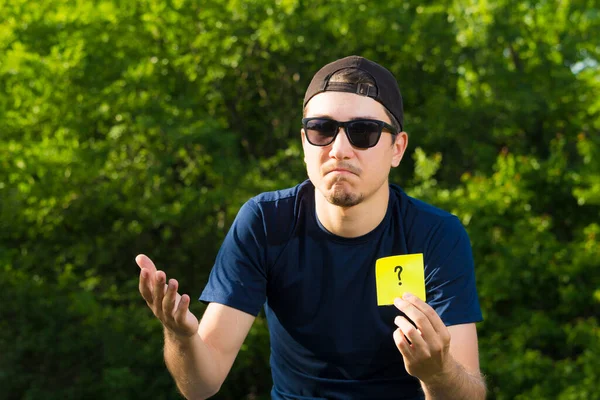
[[200, 180, 482, 400]]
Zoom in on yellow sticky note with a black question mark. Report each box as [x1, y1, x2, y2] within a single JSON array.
[[375, 253, 425, 306]]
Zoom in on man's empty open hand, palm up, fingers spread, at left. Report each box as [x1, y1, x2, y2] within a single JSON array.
[[135, 254, 198, 339]]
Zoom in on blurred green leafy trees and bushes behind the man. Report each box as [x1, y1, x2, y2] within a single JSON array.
[[0, 0, 600, 400]]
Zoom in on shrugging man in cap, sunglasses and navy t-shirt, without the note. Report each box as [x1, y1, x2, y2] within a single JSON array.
[[136, 56, 485, 399]]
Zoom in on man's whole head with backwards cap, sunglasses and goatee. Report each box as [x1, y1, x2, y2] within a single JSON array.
[[302, 56, 408, 207]]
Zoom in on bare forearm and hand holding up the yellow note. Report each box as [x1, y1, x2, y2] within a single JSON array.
[[394, 295, 486, 400]]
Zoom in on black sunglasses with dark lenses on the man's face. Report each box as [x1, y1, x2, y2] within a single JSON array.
[[302, 118, 398, 149]]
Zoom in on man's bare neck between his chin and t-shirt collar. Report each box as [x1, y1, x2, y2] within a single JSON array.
[[315, 182, 390, 238]]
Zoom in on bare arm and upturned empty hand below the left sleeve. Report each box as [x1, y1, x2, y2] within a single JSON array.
[[136, 255, 254, 400]]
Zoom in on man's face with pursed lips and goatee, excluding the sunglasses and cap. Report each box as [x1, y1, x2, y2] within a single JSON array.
[[302, 92, 408, 207]]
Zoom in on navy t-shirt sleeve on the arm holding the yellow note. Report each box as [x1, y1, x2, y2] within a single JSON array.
[[424, 216, 483, 326]]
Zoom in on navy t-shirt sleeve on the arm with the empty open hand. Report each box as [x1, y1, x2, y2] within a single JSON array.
[[200, 200, 267, 316]]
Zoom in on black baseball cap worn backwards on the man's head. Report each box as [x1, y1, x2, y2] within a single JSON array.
[[303, 56, 404, 131]]
